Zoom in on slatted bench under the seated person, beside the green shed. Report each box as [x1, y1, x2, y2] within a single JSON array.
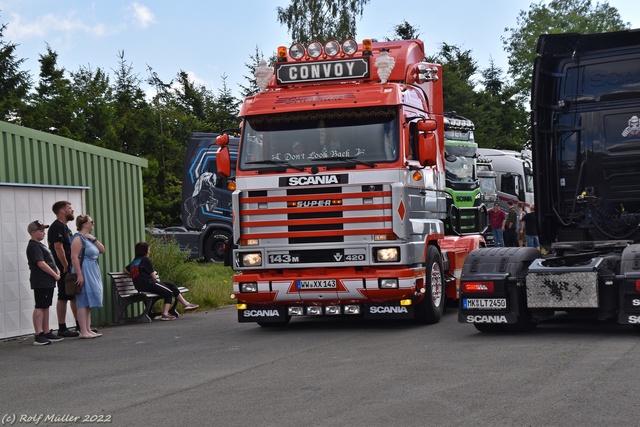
[[109, 271, 189, 325]]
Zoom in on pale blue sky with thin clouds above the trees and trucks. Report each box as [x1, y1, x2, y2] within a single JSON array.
[[0, 0, 640, 97]]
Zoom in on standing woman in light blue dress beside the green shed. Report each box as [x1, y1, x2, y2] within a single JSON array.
[[71, 215, 104, 339]]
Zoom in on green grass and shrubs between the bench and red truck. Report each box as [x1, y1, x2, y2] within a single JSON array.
[[147, 235, 233, 311]]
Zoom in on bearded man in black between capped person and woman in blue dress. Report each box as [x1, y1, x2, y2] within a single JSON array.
[[47, 200, 80, 337]]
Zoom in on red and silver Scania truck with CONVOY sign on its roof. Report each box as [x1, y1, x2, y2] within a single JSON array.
[[217, 40, 484, 326]]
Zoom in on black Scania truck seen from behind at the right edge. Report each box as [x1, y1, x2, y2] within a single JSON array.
[[458, 30, 640, 332]]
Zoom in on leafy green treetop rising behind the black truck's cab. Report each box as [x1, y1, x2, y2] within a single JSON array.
[[502, 0, 630, 99]]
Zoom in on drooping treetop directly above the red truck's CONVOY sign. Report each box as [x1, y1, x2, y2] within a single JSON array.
[[277, 0, 370, 43]]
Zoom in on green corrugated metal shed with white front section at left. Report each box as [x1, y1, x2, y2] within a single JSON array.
[[0, 121, 147, 338]]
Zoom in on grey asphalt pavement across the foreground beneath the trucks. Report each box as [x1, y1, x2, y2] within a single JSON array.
[[0, 307, 640, 427]]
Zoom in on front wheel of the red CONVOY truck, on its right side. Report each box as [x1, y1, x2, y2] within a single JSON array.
[[415, 246, 446, 325]]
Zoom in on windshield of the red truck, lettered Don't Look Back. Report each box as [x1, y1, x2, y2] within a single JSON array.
[[238, 107, 399, 171]]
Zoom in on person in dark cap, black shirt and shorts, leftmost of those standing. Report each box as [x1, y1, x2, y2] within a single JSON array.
[[27, 221, 62, 345]]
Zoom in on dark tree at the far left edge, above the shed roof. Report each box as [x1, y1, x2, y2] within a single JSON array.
[[0, 24, 32, 123]]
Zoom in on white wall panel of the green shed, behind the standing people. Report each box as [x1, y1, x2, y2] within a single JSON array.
[[0, 185, 86, 339]]
